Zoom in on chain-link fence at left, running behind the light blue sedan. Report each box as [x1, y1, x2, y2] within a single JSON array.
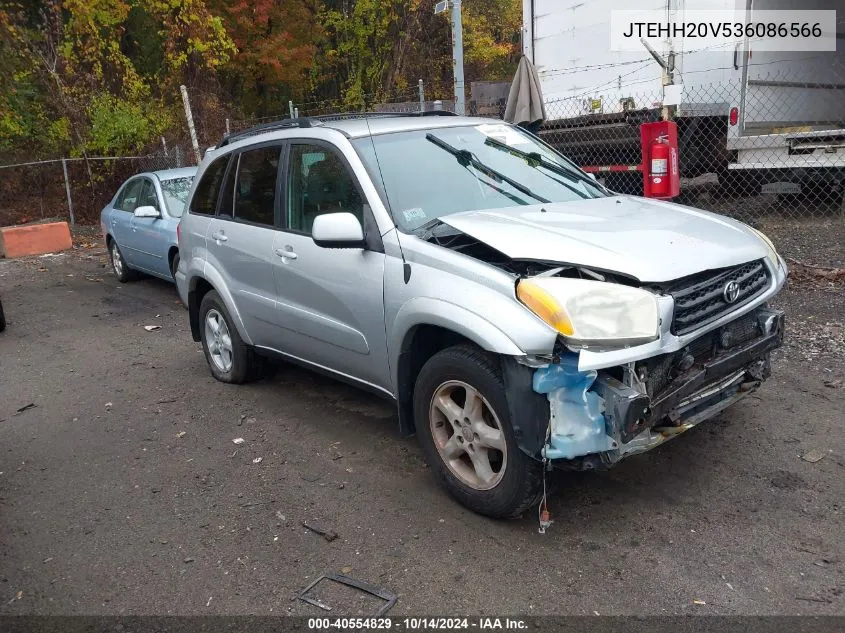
[[0, 147, 188, 226]]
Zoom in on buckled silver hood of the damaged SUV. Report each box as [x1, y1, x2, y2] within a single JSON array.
[[440, 196, 767, 282]]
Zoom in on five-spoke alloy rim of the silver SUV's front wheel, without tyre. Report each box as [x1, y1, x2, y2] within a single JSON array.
[[429, 380, 508, 490]]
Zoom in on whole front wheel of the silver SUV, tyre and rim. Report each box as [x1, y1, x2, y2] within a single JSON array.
[[414, 345, 543, 518]]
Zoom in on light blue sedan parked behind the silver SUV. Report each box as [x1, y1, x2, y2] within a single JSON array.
[[100, 167, 197, 281]]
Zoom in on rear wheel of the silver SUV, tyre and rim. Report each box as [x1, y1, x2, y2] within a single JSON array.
[[199, 290, 263, 384]]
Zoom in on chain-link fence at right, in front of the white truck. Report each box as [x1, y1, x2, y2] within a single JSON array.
[[539, 67, 845, 218]]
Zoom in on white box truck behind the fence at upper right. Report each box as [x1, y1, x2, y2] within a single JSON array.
[[523, 0, 845, 193]]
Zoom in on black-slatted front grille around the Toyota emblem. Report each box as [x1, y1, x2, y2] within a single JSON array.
[[669, 260, 769, 334]]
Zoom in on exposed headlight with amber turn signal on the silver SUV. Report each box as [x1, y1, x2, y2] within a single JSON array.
[[516, 277, 660, 347]]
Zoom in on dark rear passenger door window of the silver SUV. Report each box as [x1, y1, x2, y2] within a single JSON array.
[[235, 147, 281, 226]]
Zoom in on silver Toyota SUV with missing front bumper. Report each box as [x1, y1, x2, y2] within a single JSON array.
[[176, 115, 786, 517]]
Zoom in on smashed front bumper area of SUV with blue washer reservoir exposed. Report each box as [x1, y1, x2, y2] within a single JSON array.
[[531, 307, 784, 470]]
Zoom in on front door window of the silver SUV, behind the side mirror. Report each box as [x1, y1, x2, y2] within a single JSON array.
[[288, 144, 364, 234]]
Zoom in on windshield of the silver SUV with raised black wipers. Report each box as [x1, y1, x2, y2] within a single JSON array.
[[353, 124, 609, 231]]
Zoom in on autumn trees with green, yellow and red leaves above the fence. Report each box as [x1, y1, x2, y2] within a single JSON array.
[[0, 0, 522, 162]]
